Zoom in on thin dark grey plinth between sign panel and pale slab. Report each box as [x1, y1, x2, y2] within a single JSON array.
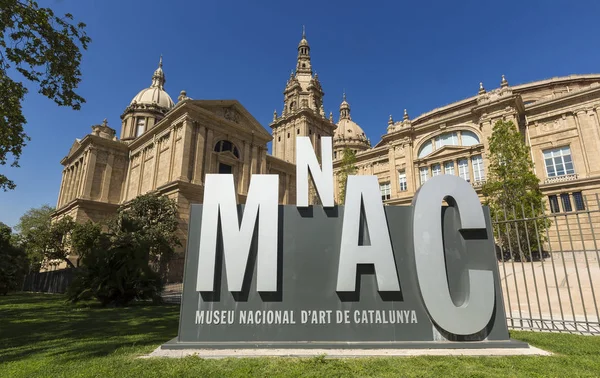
[[159, 338, 529, 354]]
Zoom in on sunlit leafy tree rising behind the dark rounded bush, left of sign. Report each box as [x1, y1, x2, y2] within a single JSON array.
[[109, 193, 181, 275]]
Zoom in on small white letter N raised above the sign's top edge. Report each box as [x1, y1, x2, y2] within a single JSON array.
[[296, 137, 334, 207]]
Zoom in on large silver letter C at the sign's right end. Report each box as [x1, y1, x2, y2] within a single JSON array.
[[412, 175, 495, 335]]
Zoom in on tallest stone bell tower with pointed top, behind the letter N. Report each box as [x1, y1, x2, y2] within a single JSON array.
[[269, 27, 336, 163]]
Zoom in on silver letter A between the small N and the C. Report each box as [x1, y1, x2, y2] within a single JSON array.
[[337, 176, 400, 292]]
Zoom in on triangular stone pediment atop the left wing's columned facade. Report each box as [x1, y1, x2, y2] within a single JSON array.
[[190, 100, 272, 140]]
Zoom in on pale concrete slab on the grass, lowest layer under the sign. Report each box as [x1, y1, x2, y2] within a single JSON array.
[[141, 344, 552, 358]]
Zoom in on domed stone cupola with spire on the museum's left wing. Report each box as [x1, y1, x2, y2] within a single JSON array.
[[121, 55, 175, 141]]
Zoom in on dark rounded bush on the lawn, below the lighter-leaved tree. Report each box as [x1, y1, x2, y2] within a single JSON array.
[[67, 234, 163, 306]]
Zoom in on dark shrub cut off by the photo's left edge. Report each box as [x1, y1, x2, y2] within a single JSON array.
[[0, 222, 28, 295]]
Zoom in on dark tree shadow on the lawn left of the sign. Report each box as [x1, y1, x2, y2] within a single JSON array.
[[0, 293, 179, 362]]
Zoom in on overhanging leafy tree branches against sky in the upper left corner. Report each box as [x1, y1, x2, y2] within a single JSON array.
[[0, 0, 91, 191]]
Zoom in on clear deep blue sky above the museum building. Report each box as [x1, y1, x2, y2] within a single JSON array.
[[0, 0, 600, 226]]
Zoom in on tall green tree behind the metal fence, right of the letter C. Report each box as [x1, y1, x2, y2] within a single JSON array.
[[482, 121, 549, 260]]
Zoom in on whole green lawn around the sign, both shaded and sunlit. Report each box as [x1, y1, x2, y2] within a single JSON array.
[[0, 293, 600, 377]]
